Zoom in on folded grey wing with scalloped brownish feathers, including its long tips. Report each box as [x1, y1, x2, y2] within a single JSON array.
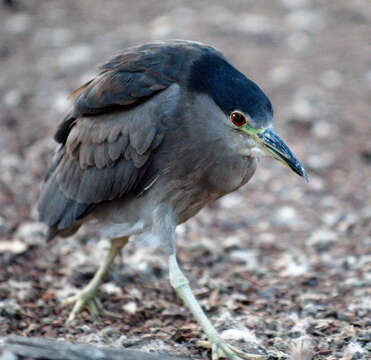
[[38, 101, 165, 233]]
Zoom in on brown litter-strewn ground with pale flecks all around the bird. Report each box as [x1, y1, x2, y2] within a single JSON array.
[[0, 0, 371, 360]]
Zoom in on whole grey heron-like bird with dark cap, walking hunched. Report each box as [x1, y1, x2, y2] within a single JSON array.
[[38, 40, 308, 360]]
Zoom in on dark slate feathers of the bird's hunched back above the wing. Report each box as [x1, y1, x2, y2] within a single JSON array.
[[55, 40, 223, 144]]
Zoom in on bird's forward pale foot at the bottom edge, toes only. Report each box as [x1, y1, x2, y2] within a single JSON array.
[[197, 335, 264, 360]]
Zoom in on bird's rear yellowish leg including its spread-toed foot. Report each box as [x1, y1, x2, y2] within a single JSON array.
[[62, 237, 128, 323]]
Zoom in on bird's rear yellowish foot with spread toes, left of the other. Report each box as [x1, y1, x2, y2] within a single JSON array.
[[62, 289, 120, 324]]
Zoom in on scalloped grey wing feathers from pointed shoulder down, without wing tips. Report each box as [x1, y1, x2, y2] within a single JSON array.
[[50, 84, 179, 203]]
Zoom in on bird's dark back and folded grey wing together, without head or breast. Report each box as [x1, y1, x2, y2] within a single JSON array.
[[38, 42, 206, 232]]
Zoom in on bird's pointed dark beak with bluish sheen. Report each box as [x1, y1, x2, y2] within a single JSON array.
[[257, 128, 308, 181]]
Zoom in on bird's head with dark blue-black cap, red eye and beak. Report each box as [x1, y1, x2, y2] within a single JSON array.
[[189, 53, 308, 181]]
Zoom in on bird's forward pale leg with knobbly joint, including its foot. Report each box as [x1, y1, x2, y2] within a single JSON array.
[[169, 254, 262, 360]]
